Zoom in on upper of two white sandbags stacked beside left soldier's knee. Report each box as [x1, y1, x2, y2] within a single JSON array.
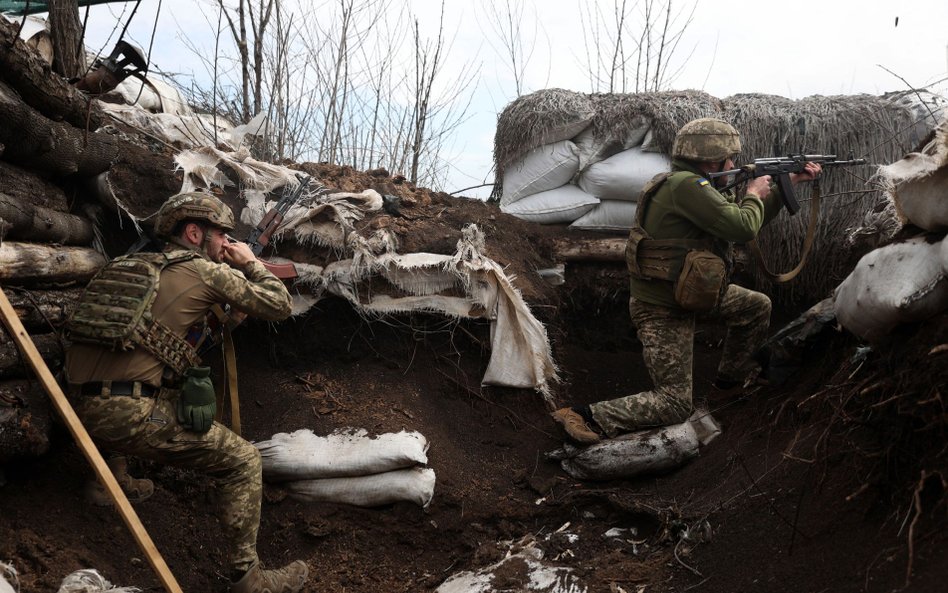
[[254, 428, 428, 481]]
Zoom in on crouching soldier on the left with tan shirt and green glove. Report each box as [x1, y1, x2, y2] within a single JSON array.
[[65, 193, 309, 593]]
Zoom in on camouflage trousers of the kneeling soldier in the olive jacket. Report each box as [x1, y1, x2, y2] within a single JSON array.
[[590, 284, 770, 437]]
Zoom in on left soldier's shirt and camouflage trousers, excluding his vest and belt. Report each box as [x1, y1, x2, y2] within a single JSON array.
[[66, 252, 290, 573]]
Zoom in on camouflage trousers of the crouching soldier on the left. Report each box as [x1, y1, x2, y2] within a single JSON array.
[[71, 390, 263, 572]]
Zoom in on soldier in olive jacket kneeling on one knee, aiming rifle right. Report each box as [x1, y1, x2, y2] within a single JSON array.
[[553, 118, 820, 444]]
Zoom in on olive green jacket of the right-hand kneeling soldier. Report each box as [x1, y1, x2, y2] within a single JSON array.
[[630, 160, 783, 309]]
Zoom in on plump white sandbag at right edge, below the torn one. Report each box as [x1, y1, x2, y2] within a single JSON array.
[[833, 237, 948, 341]]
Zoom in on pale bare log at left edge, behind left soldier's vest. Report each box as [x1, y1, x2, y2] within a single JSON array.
[[0, 241, 106, 285]]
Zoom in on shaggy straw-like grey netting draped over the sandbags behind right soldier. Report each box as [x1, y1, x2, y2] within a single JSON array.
[[493, 89, 944, 304]]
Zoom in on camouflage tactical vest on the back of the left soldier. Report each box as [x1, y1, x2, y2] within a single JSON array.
[[66, 250, 200, 376]]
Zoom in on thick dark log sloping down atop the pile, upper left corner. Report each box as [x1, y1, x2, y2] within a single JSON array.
[[0, 19, 107, 130]]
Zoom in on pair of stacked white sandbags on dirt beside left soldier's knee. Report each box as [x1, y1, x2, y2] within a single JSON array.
[[255, 429, 435, 507]]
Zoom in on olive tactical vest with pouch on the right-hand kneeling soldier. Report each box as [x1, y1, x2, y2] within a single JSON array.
[[625, 171, 728, 312]]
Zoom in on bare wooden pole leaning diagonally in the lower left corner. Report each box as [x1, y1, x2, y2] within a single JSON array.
[[0, 288, 182, 593]]
